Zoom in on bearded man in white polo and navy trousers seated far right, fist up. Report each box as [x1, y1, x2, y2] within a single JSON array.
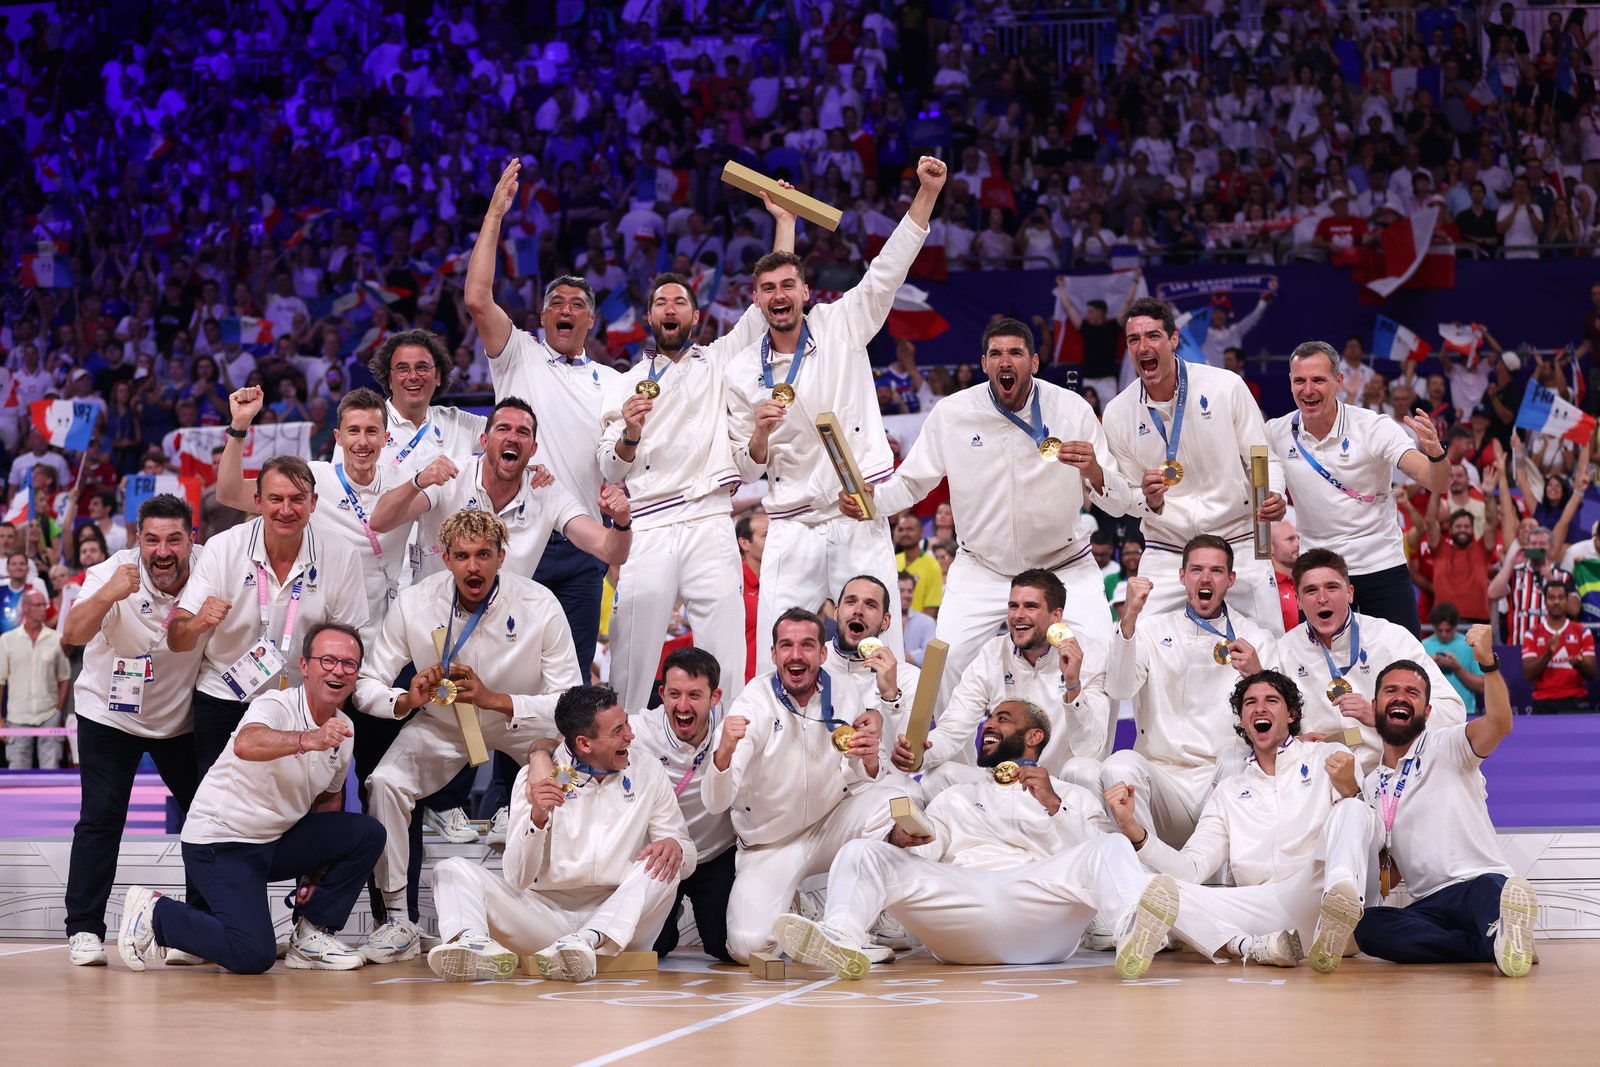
[[1355, 625, 1539, 977]]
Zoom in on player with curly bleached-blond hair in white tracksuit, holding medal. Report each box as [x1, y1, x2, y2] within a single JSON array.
[[355, 510, 582, 963]]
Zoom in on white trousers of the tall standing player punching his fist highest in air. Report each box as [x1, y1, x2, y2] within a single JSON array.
[[758, 515, 908, 659]]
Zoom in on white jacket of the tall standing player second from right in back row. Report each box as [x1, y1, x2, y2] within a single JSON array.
[[1104, 363, 1283, 552]]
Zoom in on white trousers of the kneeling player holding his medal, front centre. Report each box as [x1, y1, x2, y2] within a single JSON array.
[[728, 780, 904, 963]]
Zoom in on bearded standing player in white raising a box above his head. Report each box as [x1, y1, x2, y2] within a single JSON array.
[[597, 182, 795, 709]]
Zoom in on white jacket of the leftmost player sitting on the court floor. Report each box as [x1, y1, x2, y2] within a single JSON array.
[[501, 745, 699, 893]]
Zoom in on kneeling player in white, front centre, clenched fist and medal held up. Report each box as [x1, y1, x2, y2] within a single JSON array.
[[701, 608, 904, 963]]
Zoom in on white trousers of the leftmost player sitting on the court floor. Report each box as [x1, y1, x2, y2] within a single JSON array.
[[434, 856, 678, 955]]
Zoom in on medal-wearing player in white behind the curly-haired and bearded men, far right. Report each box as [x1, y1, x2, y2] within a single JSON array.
[[1278, 549, 1467, 774]]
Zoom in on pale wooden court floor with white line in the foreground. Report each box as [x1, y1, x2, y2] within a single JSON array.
[[9, 941, 1600, 1067]]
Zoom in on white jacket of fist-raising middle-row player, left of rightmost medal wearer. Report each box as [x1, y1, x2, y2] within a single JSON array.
[[1106, 611, 1280, 795]]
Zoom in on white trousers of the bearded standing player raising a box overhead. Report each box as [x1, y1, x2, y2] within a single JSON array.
[[611, 515, 748, 712]]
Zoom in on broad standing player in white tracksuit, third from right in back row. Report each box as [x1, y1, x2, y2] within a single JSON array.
[[857, 318, 1131, 693]]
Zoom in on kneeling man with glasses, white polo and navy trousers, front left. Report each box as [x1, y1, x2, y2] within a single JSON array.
[[117, 622, 384, 974]]
